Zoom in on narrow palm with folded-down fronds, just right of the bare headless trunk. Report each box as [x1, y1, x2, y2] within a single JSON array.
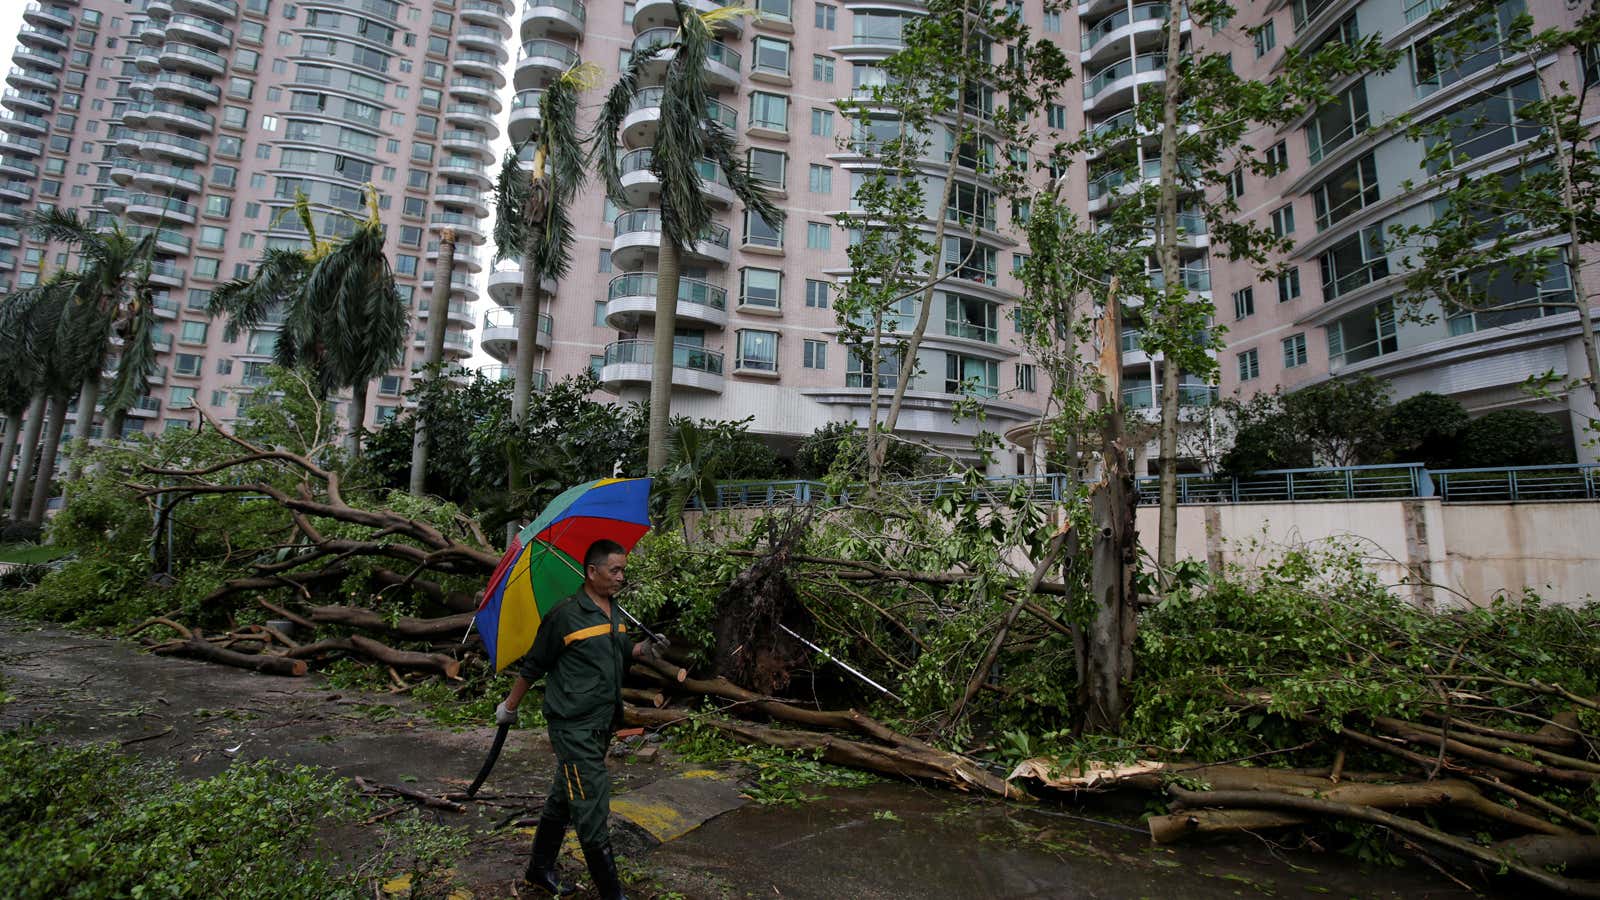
[[494, 62, 600, 423]]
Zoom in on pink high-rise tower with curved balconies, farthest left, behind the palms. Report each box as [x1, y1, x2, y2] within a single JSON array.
[[0, 0, 514, 434]]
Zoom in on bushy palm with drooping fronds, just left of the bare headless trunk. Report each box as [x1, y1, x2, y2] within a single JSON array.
[[210, 184, 411, 455]]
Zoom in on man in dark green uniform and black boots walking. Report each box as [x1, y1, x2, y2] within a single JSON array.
[[494, 540, 658, 900]]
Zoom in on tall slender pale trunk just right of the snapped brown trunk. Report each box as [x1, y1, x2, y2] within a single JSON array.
[[1158, 0, 1187, 591]]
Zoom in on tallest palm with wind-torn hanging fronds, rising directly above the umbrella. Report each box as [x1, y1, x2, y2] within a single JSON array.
[[592, 0, 782, 471]]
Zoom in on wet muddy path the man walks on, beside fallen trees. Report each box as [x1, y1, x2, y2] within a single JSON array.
[[0, 621, 1470, 900]]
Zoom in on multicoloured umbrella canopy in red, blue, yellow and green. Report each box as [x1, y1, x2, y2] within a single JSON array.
[[472, 479, 650, 673]]
